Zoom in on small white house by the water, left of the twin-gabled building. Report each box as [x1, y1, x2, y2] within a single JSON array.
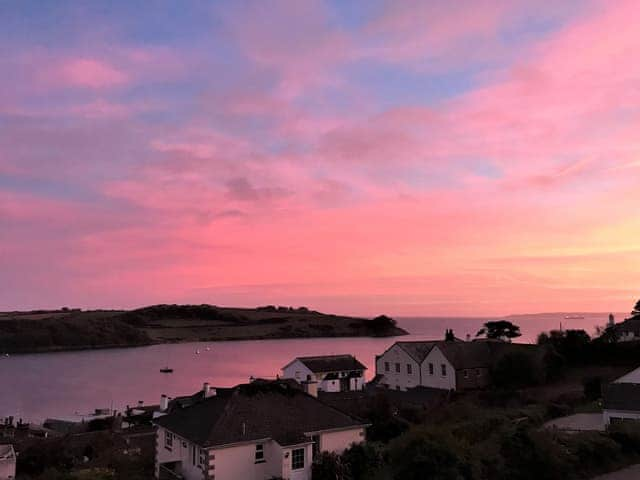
[[282, 355, 367, 392]]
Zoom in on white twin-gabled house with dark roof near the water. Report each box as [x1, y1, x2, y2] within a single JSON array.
[[376, 339, 539, 391]]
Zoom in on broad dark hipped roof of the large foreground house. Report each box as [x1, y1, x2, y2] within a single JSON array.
[[155, 381, 364, 447]]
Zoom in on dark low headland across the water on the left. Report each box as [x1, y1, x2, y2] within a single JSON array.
[[0, 305, 407, 353]]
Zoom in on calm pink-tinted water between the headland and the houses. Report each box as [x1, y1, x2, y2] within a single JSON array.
[[0, 314, 622, 422]]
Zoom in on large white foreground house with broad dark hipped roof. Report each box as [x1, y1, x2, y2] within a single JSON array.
[[154, 380, 367, 480]]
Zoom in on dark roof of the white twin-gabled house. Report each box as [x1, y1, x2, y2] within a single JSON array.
[[397, 340, 537, 370]]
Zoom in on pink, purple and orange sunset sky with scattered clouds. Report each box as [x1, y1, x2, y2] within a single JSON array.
[[0, 0, 640, 316]]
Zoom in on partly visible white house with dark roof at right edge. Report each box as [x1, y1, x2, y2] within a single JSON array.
[[603, 368, 640, 425]]
